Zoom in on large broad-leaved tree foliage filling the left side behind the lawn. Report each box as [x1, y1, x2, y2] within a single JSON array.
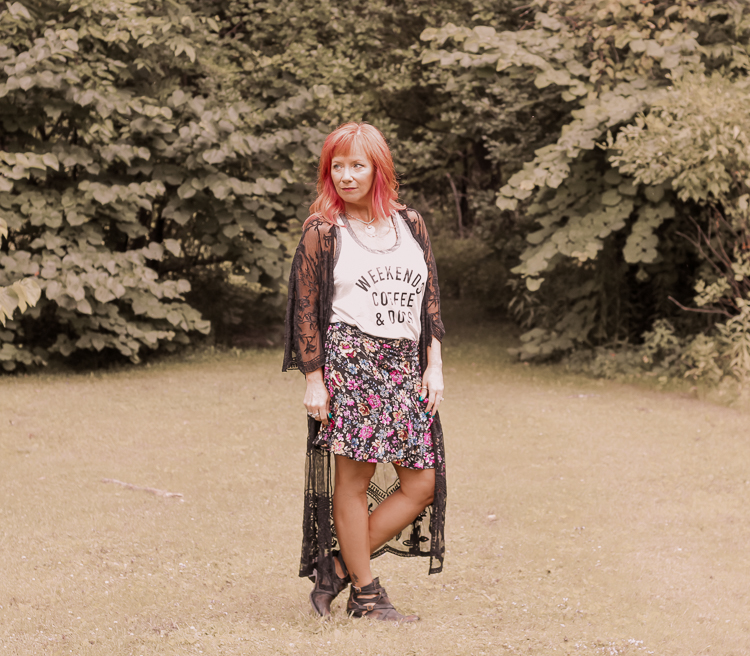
[[0, 0, 308, 367]]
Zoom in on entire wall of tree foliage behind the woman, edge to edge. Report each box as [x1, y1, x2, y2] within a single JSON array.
[[0, 0, 750, 377]]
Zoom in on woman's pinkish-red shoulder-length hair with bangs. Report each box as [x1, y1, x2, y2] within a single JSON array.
[[308, 123, 406, 224]]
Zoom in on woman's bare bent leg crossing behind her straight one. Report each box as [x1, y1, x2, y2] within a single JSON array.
[[368, 461, 435, 556]]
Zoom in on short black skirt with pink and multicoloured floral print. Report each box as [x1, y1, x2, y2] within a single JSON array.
[[314, 323, 435, 469]]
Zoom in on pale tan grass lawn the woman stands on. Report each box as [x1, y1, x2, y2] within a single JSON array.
[[0, 320, 750, 656]]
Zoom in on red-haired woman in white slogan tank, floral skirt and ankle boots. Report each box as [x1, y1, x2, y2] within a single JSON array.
[[283, 123, 446, 622]]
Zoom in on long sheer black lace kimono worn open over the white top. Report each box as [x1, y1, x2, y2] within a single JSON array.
[[282, 210, 446, 578]]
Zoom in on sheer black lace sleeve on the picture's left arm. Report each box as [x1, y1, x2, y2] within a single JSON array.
[[282, 219, 333, 373]]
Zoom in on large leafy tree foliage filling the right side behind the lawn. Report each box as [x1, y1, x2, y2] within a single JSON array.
[[422, 0, 750, 368]]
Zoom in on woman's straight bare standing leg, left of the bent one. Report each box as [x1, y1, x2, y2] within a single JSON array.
[[333, 456, 375, 587]]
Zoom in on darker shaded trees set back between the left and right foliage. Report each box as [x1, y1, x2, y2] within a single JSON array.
[[217, 0, 536, 303]]
